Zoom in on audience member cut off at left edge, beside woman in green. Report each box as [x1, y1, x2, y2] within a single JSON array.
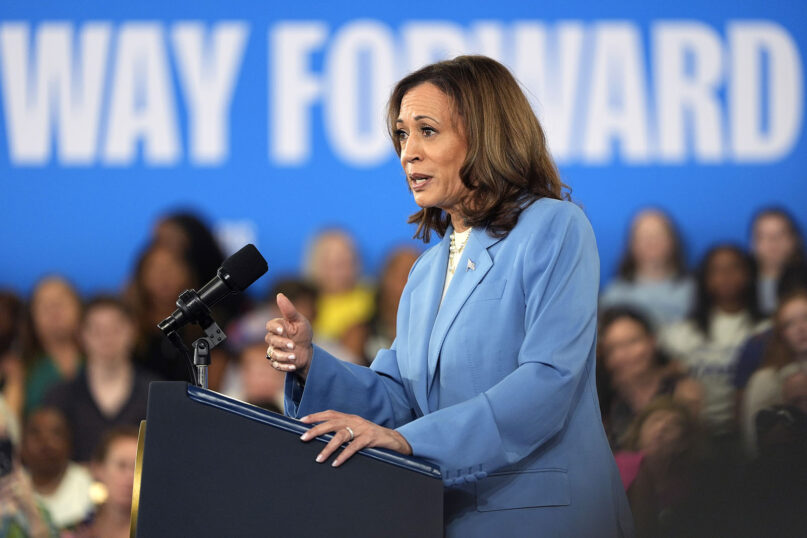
[[0, 290, 25, 419]]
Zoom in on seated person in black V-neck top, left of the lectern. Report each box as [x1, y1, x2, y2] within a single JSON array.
[[45, 296, 155, 462]]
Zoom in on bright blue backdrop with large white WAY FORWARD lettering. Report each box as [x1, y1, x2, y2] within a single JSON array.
[[0, 0, 807, 292]]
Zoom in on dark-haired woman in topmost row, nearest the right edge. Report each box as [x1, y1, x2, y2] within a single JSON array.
[[751, 207, 807, 314]]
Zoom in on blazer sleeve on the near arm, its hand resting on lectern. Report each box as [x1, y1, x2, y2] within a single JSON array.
[[398, 204, 599, 485]]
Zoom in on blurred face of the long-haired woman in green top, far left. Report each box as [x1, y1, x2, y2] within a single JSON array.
[[31, 279, 81, 340]]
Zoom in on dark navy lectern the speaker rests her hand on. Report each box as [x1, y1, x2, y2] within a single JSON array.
[[136, 382, 443, 538]]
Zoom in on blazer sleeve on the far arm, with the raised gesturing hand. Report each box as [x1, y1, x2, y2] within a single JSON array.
[[284, 343, 414, 428]]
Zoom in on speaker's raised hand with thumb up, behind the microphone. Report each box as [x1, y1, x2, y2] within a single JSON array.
[[265, 293, 314, 379]]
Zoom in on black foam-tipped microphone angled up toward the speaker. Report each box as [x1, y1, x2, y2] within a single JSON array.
[[157, 244, 269, 335]]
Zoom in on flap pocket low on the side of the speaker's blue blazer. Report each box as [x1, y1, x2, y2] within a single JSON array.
[[476, 469, 571, 512]]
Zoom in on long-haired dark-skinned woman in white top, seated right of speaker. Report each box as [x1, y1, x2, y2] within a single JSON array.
[[660, 245, 766, 436]]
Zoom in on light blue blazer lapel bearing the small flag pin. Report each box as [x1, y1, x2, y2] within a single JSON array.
[[426, 228, 499, 398]]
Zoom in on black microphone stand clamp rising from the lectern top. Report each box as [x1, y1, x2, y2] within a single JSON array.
[[159, 290, 227, 389]]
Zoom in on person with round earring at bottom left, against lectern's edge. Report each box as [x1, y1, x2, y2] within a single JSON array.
[[74, 426, 137, 538]]
